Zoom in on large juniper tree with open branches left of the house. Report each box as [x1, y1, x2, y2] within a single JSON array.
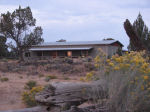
[[0, 6, 43, 61]]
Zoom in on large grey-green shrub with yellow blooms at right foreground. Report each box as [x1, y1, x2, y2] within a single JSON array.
[[95, 51, 150, 112]]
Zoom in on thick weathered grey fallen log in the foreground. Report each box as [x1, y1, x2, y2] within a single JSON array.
[[35, 82, 107, 110]]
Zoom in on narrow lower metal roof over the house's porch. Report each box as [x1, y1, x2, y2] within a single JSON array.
[[29, 47, 92, 51]]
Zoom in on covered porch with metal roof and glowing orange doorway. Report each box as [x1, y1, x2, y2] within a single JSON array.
[[25, 47, 92, 59]]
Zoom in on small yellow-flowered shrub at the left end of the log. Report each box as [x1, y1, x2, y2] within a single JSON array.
[[22, 87, 43, 107]]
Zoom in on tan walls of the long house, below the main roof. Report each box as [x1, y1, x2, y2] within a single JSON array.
[[24, 45, 120, 58]]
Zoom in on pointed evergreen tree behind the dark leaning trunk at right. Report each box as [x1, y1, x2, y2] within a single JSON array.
[[128, 13, 150, 51]]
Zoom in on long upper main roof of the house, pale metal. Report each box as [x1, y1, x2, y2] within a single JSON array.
[[34, 40, 123, 46]]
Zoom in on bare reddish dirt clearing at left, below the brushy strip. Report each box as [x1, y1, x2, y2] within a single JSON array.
[[0, 72, 82, 110]]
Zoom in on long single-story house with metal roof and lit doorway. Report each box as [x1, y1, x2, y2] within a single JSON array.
[[24, 39, 123, 59]]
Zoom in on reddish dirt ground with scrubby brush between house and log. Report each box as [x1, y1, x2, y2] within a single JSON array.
[[0, 59, 95, 110]]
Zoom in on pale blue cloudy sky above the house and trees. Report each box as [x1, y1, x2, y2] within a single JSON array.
[[0, 0, 150, 49]]
